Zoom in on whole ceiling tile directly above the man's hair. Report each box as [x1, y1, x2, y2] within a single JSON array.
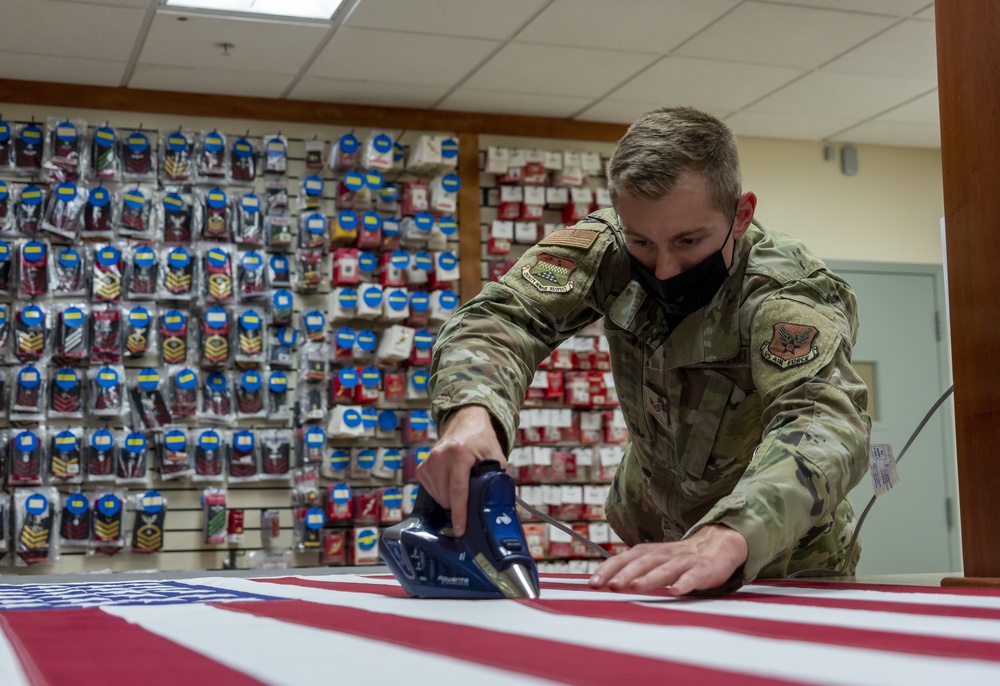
[[609, 57, 803, 110]]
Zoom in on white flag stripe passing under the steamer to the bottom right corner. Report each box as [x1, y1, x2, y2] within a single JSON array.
[[199, 576, 1000, 686]]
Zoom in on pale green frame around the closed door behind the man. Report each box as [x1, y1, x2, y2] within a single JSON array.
[[824, 260, 962, 572]]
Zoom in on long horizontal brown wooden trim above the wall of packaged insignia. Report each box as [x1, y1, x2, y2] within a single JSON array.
[[0, 79, 627, 142]]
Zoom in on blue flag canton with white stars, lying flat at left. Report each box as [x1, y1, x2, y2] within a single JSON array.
[[0, 581, 279, 610]]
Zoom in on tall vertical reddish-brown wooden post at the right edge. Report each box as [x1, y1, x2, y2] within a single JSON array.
[[935, 0, 1000, 578]]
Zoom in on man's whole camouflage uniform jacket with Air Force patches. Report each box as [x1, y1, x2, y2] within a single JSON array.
[[431, 210, 871, 584]]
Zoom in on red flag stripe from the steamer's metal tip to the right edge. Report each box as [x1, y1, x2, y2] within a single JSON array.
[[519, 600, 1000, 662]]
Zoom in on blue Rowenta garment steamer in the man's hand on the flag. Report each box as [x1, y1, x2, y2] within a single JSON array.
[[379, 460, 539, 599]]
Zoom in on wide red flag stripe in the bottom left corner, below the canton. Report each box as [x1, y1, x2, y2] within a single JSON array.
[[0, 608, 263, 686]]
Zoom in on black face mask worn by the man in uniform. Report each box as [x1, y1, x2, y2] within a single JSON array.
[[628, 222, 736, 316]]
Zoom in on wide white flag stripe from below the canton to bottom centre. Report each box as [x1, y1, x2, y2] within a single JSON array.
[[104, 604, 552, 686]]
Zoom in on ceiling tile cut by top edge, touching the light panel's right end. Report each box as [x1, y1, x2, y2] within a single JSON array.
[[345, 0, 547, 39]]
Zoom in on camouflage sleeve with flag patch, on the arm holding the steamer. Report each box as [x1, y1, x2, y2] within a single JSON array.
[[430, 228, 614, 452]]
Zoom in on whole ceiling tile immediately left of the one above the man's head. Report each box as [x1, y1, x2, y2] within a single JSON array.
[[464, 43, 656, 98]]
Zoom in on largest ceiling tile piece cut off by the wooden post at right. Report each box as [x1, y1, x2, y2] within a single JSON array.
[[823, 19, 937, 79]]
